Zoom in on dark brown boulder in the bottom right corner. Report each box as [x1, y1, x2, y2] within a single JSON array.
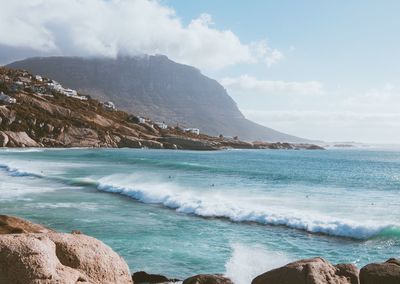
[[360, 258, 400, 284]]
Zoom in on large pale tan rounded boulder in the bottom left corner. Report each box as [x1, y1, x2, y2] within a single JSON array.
[[0, 225, 132, 284]]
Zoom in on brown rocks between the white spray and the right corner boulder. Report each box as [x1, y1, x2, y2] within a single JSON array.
[[251, 257, 359, 284]]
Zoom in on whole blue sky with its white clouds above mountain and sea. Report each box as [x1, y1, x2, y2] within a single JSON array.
[[0, 0, 400, 144]]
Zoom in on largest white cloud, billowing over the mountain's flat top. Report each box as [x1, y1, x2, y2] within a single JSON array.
[[0, 0, 283, 69]]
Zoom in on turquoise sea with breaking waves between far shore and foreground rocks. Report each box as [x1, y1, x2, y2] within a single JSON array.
[[0, 149, 400, 284]]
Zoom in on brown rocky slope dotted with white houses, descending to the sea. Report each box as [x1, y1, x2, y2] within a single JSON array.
[[0, 68, 318, 150]]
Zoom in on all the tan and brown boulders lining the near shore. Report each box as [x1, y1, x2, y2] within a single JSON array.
[[0, 215, 400, 284]]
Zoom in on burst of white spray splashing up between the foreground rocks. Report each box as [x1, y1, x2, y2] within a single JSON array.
[[225, 243, 291, 284]]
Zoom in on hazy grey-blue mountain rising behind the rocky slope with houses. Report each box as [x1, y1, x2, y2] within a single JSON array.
[[8, 55, 306, 142]]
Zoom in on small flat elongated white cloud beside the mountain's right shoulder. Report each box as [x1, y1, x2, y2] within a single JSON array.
[[220, 75, 324, 95]]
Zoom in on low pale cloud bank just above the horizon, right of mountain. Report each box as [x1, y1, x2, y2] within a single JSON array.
[[243, 108, 400, 144]]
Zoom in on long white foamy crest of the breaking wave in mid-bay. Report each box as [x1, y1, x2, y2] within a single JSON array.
[[98, 174, 400, 239]]
